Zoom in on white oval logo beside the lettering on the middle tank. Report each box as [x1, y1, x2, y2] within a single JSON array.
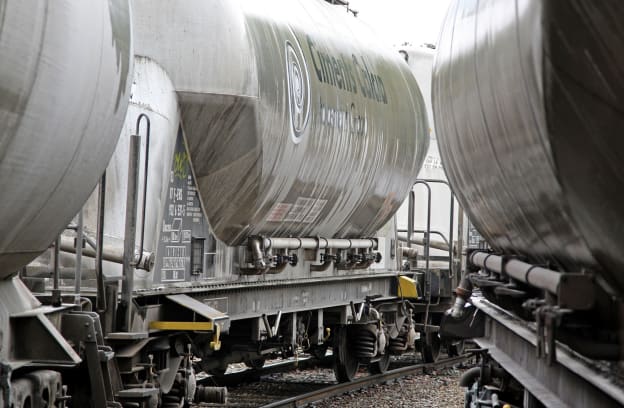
[[286, 41, 310, 143]]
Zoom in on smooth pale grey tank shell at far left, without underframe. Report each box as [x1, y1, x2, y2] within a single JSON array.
[[0, 0, 132, 278]]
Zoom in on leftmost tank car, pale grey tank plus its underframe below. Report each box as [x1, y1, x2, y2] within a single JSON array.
[[0, 0, 132, 407]]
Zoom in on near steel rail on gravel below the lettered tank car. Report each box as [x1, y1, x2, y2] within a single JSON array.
[[262, 354, 474, 408]]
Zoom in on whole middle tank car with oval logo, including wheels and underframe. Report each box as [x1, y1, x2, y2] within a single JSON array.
[[0, 0, 453, 408]]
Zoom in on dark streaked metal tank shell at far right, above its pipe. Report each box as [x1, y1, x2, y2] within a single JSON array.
[[432, 0, 624, 293]]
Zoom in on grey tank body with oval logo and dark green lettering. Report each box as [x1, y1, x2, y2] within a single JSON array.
[[132, 0, 428, 245]]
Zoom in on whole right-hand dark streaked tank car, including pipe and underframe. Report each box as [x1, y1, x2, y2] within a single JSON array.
[[432, 0, 624, 407]]
